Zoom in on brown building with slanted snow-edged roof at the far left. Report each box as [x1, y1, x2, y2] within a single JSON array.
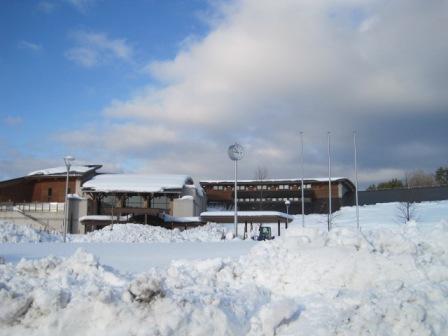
[[0, 165, 102, 233]]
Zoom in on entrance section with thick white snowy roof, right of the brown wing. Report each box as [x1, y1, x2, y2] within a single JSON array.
[[82, 174, 207, 231]]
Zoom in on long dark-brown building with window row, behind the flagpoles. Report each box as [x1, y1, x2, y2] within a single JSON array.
[[200, 178, 355, 214]]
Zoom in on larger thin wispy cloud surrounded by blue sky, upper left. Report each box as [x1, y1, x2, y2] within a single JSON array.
[[65, 31, 133, 68]]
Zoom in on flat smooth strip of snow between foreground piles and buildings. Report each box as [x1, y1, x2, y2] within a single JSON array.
[[0, 240, 256, 273]]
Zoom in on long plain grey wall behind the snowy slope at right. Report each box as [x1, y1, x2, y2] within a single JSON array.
[[359, 186, 448, 205]]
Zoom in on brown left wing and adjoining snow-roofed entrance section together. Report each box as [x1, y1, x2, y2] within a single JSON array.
[[0, 165, 206, 233]]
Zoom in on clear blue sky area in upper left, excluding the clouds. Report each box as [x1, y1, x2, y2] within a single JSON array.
[[0, 0, 208, 169]]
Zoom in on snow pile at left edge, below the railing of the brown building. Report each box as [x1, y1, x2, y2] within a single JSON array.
[[0, 221, 62, 243]]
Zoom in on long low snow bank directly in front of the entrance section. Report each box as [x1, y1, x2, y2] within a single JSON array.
[[69, 224, 225, 243]]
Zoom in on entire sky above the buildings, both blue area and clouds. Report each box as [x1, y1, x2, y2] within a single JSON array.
[[0, 0, 448, 186]]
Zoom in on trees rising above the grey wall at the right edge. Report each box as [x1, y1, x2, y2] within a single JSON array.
[[367, 166, 448, 190]]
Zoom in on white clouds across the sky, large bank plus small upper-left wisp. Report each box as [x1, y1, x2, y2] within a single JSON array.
[[59, 0, 448, 185]]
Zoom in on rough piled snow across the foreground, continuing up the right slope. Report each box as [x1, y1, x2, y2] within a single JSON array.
[[0, 201, 448, 335]]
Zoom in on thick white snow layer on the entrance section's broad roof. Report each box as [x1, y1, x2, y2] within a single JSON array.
[[82, 174, 193, 193]]
